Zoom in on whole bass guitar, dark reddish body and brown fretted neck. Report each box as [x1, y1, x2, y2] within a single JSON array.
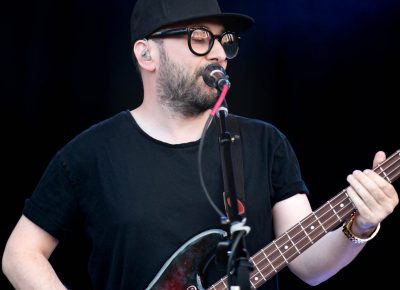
[[146, 150, 400, 290]]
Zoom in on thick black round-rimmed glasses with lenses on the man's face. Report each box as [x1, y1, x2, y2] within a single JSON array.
[[147, 27, 240, 59]]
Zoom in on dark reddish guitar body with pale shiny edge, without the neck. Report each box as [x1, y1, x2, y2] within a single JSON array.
[[146, 229, 227, 290]]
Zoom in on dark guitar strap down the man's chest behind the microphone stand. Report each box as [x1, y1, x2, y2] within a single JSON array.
[[219, 114, 246, 221]]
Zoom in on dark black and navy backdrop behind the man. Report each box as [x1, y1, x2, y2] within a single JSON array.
[[0, 0, 400, 290]]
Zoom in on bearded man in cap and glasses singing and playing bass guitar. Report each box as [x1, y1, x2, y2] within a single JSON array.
[[2, 0, 398, 290]]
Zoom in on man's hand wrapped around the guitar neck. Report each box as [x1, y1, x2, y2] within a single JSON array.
[[347, 151, 399, 237]]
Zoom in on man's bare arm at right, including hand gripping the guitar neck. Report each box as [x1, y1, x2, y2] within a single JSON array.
[[273, 152, 399, 285]]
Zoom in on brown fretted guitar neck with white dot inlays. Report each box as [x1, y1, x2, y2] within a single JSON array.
[[208, 150, 400, 290]]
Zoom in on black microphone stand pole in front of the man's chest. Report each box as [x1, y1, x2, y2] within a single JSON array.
[[217, 106, 253, 290]]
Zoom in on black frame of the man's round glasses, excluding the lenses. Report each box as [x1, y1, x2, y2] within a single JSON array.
[[145, 27, 240, 59]]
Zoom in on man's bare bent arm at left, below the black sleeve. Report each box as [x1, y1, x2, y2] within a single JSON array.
[[2, 216, 66, 290]]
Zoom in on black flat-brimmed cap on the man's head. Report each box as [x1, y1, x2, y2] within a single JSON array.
[[131, 0, 254, 44]]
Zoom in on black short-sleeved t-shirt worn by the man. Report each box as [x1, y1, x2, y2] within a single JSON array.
[[23, 110, 307, 290]]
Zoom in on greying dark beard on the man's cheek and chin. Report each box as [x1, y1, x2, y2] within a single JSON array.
[[157, 45, 218, 117]]
